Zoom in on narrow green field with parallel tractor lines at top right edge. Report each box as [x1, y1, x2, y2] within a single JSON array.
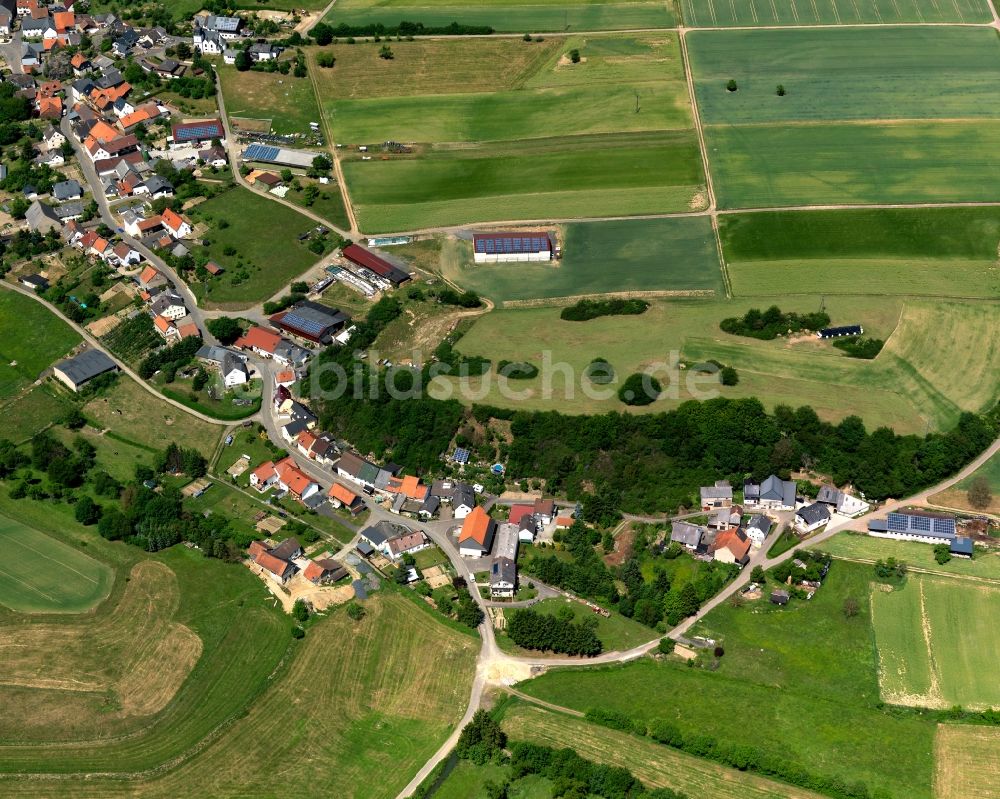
[[681, 0, 990, 28]]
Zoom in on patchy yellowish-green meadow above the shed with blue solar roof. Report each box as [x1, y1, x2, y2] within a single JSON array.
[[218, 64, 320, 134]]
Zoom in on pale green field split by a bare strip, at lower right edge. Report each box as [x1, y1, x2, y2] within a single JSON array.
[[871, 574, 1000, 709]]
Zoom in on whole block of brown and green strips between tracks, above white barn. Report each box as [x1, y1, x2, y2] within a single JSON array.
[[314, 33, 705, 232]]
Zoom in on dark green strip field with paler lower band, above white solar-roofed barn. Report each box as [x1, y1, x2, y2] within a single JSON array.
[[344, 131, 704, 232]]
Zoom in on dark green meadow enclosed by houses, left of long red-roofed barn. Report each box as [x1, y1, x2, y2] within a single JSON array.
[[191, 187, 332, 307]]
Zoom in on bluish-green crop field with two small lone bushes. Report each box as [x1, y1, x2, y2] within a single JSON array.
[[687, 27, 1000, 125]]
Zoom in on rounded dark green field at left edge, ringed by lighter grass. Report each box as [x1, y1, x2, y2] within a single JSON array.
[[0, 516, 114, 613]]
